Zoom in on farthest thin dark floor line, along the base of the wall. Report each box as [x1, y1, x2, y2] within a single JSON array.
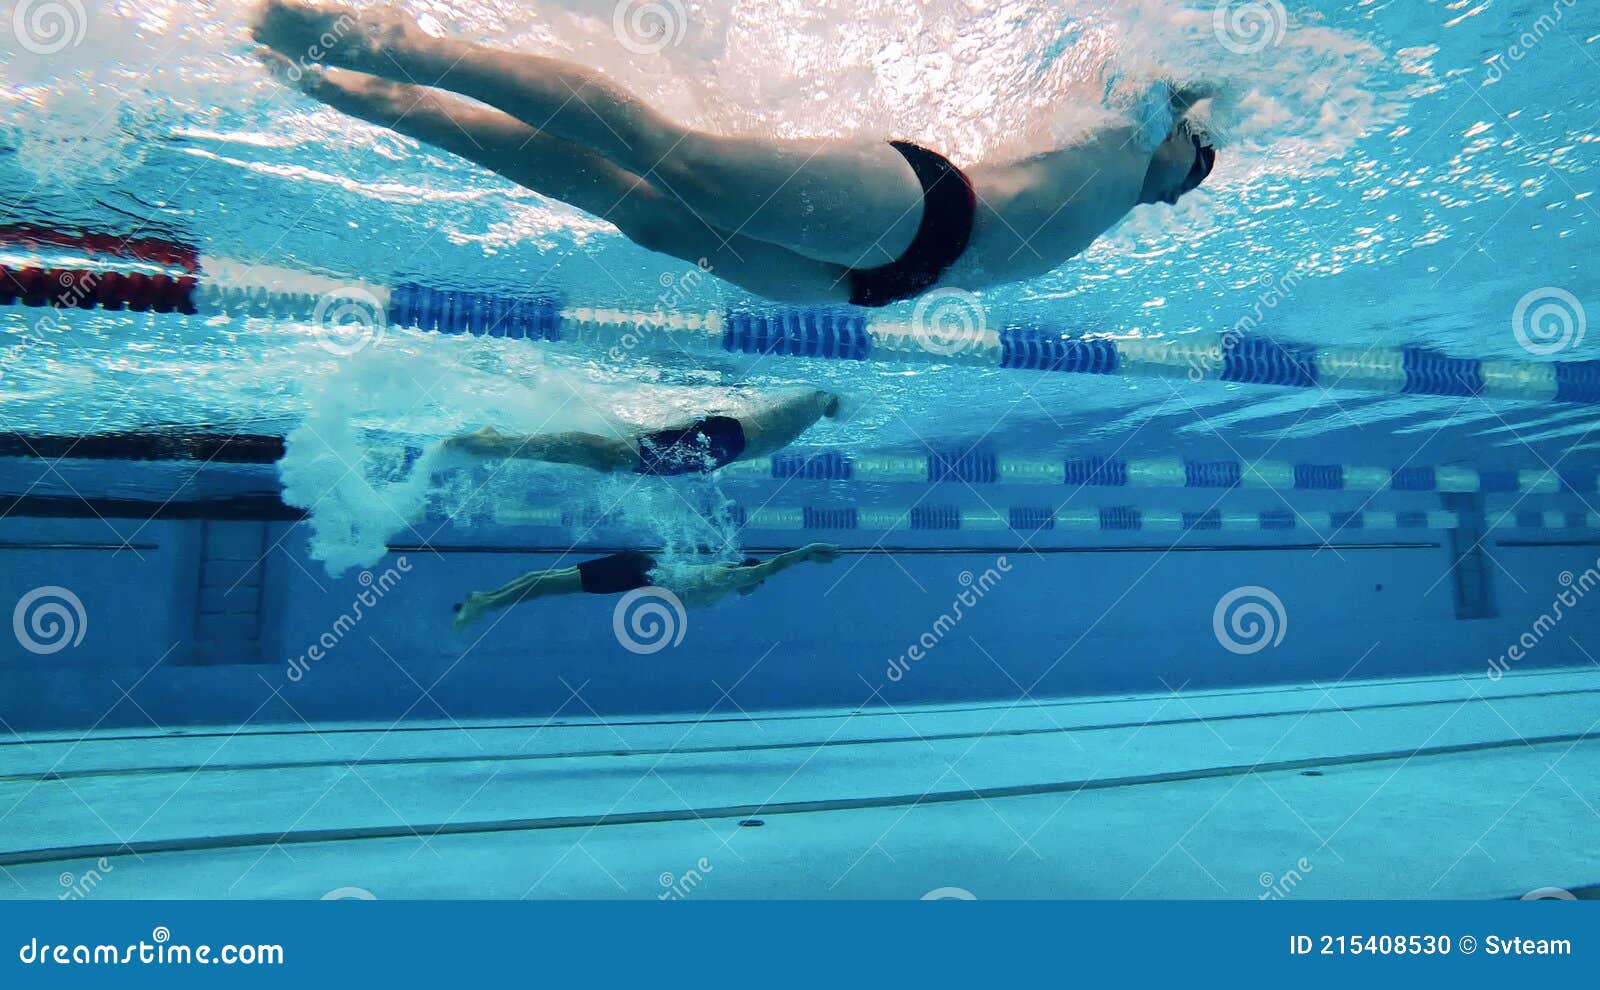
[[0, 667, 1595, 748]]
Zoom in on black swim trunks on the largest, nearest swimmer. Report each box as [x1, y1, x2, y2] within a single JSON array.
[[850, 141, 978, 307]]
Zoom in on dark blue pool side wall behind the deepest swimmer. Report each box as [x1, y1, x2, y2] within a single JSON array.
[[0, 518, 1600, 731]]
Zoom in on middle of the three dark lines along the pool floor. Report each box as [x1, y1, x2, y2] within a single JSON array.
[[0, 688, 1600, 784]]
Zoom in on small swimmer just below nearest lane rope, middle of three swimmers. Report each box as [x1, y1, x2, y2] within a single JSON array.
[[445, 390, 840, 477]]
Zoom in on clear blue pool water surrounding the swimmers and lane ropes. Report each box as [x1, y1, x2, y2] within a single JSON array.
[[0, 0, 1600, 899]]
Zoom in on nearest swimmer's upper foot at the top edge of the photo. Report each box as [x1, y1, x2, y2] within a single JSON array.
[[251, 0, 430, 72]]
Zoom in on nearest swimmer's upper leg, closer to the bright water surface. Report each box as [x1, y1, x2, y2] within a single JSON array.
[[254, 0, 922, 269]]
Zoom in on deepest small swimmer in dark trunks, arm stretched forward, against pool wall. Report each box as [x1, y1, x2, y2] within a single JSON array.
[[453, 544, 840, 632]]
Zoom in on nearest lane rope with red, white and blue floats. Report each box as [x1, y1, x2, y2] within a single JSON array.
[[9, 257, 1600, 405]]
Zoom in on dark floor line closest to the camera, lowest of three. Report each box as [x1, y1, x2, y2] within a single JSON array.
[[0, 733, 1600, 867]]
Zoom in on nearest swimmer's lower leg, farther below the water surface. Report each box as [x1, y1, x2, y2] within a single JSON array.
[[270, 56, 850, 302]]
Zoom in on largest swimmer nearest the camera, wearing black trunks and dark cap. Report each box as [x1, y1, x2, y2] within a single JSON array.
[[254, 0, 1216, 307]]
